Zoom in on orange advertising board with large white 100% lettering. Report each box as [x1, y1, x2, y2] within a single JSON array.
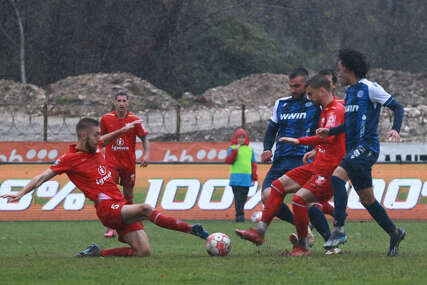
[[0, 161, 427, 221]]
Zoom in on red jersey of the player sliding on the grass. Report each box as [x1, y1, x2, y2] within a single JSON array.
[[50, 144, 125, 205]]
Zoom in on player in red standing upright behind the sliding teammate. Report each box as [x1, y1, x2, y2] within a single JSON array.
[[101, 90, 150, 237]]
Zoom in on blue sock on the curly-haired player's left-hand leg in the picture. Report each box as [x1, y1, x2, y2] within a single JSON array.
[[331, 176, 347, 227]]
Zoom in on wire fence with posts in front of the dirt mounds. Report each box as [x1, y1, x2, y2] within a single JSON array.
[[0, 105, 271, 141]]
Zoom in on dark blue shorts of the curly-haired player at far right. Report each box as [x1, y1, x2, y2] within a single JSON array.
[[340, 146, 379, 191]]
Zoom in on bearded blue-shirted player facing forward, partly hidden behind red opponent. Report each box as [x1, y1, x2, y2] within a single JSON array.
[[261, 68, 321, 240]]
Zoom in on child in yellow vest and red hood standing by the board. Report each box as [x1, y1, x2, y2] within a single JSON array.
[[225, 128, 258, 222]]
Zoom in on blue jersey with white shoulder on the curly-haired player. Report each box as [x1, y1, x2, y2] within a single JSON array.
[[345, 78, 394, 153]]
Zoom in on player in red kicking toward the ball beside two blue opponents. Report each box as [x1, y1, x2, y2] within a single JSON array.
[[236, 74, 345, 256]]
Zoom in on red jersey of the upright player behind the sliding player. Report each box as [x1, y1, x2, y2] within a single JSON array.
[[101, 111, 148, 169]]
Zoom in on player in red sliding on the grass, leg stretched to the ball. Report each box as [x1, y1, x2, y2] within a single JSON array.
[[1, 118, 209, 257]]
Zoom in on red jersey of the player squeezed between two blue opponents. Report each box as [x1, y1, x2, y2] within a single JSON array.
[[298, 98, 345, 168]]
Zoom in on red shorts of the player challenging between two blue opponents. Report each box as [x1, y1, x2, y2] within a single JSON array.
[[286, 164, 336, 202]]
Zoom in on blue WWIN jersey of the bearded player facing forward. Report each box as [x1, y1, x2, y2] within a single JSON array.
[[270, 96, 321, 160]]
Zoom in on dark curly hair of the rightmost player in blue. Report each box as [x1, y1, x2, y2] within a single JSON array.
[[338, 48, 369, 78]]
